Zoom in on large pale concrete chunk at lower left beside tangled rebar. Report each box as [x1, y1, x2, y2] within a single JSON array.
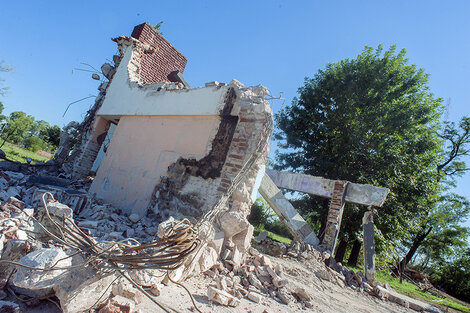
[[10, 248, 72, 297]]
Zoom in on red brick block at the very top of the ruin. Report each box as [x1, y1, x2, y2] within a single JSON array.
[[131, 23, 188, 83]]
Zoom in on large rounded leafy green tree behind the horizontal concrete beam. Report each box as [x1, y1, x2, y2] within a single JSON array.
[[275, 46, 442, 263]]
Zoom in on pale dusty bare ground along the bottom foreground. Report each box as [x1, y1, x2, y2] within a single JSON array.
[[136, 257, 416, 313]]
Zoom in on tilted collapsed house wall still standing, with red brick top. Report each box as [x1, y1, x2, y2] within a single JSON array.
[[53, 24, 272, 274]]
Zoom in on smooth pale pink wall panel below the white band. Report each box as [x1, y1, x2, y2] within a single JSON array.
[[90, 116, 220, 215]]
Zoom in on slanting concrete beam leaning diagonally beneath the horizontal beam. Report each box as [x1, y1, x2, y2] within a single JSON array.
[[259, 174, 319, 246]]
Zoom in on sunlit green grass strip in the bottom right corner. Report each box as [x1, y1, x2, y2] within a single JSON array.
[[347, 266, 470, 313]]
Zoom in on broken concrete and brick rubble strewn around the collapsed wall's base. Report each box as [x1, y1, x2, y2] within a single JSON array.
[[0, 165, 444, 312]]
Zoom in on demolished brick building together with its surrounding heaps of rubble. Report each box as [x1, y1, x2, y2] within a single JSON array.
[[0, 23, 440, 312]]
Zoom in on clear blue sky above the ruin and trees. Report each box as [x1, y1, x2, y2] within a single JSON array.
[[0, 0, 470, 226]]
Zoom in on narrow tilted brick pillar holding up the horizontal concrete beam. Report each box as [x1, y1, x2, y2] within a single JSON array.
[[322, 181, 348, 253]]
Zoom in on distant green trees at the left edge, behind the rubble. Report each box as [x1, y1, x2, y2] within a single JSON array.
[[0, 102, 61, 153]]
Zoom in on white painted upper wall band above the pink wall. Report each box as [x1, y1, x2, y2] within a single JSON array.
[[97, 45, 228, 119]]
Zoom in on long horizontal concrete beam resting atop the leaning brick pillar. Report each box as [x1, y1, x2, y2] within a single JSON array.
[[266, 170, 390, 207]]
